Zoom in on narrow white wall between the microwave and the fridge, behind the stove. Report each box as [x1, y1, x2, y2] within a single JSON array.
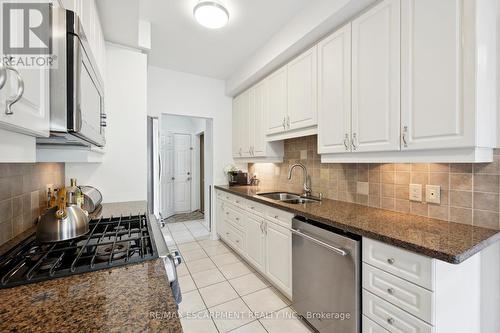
[[66, 44, 147, 202]]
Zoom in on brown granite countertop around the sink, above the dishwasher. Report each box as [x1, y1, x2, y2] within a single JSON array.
[[215, 186, 500, 264]]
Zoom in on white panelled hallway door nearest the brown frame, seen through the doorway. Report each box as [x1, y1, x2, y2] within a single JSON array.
[[174, 134, 192, 213]]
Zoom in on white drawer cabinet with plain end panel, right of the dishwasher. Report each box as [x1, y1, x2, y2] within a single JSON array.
[[362, 238, 483, 333]]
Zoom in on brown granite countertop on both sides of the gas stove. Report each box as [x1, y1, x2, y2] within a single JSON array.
[[0, 202, 182, 332]]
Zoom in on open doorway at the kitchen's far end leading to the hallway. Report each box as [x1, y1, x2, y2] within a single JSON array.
[[160, 114, 213, 230]]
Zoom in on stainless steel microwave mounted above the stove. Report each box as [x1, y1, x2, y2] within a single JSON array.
[[37, 7, 106, 147]]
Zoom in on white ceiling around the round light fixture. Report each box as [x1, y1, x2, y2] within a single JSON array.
[[97, 0, 315, 79]]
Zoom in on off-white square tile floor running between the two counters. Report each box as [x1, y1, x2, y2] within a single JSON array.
[[162, 221, 311, 333]]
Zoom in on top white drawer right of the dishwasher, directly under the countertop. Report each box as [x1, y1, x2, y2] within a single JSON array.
[[363, 238, 434, 290]]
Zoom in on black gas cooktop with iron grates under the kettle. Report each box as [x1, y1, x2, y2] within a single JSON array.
[[0, 214, 158, 289]]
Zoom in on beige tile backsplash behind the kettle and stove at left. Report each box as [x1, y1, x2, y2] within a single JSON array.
[[0, 163, 64, 244]]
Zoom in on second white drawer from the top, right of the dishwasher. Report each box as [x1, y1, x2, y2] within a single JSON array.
[[362, 263, 433, 324]]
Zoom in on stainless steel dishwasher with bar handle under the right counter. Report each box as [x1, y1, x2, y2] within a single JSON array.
[[292, 217, 361, 333]]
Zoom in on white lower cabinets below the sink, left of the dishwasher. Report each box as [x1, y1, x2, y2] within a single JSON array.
[[216, 191, 293, 299]]
